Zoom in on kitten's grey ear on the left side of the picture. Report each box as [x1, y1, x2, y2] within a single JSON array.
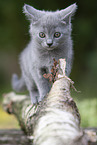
[[23, 4, 44, 24]]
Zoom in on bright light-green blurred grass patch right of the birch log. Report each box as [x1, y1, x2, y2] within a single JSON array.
[[77, 98, 97, 127]]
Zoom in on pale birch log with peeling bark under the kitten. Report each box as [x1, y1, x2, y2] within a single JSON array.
[[3, 59, 97, 145]]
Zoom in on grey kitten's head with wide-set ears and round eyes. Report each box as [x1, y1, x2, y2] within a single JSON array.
[[24, 4, 77, 50]]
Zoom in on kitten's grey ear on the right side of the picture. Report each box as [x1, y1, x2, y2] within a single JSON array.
[[60, 3, 77, 24]]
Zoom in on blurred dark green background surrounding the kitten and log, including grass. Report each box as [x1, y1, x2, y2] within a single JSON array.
[[0, 0, 97, 128]]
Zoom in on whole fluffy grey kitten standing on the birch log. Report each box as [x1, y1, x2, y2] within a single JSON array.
[[12, 4, 77, 104]]
